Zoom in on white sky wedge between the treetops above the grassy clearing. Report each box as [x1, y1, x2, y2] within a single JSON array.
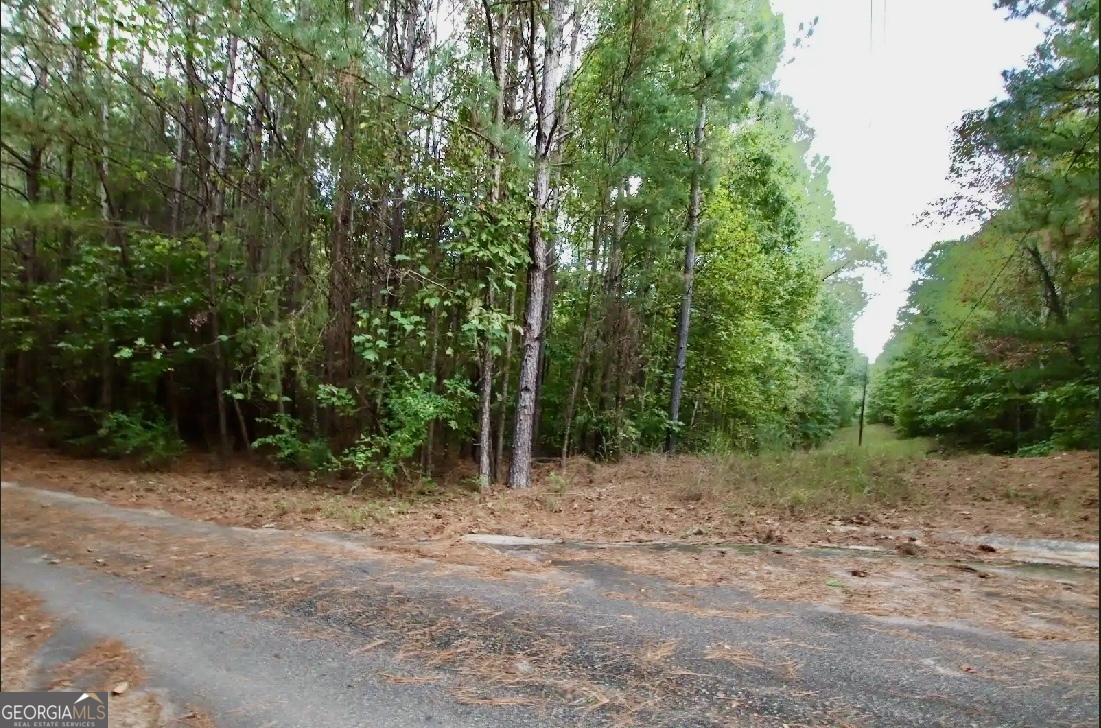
[[772, 0, 1042, 358]]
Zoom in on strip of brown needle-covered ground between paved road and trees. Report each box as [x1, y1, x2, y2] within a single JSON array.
[[0, 437, 1098, 559]]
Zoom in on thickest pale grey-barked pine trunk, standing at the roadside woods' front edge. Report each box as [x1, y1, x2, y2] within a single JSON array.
[[509, 0, 565, 488]]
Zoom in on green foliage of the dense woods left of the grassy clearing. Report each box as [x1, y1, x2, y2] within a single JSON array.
[[0, 0, 876, 473]]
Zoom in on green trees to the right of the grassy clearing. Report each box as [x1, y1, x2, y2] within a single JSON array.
[[870, 0, 1099, 455]]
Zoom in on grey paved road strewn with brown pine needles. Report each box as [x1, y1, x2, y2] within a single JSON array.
[[2, 488, 1098, 728]]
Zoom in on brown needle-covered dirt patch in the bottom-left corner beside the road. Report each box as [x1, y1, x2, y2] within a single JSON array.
[[0, 589, 215, 728]]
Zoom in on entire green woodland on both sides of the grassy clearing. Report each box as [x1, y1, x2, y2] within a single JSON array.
[[0, 0, 1098, 487]]
